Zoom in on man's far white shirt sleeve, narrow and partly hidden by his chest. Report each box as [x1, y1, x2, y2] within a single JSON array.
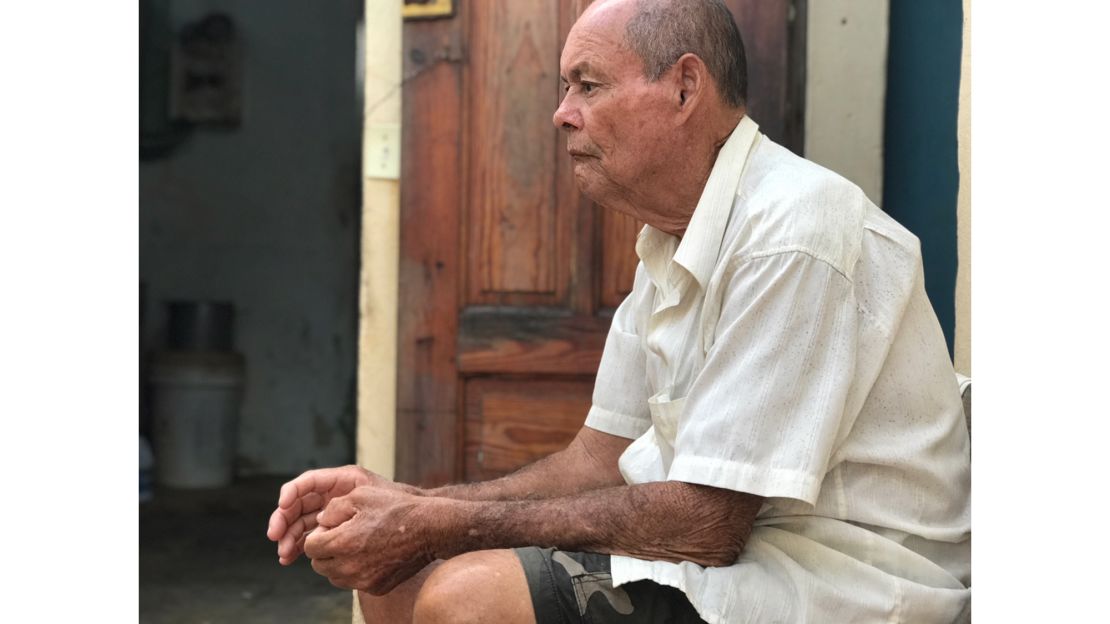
[[586, 265, 652, 440]]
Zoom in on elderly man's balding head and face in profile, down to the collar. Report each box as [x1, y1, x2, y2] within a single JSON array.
[[552, 0, 746, 232]]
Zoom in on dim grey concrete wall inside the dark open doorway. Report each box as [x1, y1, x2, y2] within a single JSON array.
[[140, 0, 362, 474]]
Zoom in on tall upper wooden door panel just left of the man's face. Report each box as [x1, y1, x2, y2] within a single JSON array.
[[464, 0, 563, 305]]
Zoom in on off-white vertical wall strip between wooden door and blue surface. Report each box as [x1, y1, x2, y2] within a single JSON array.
[[805, 0, 890, 204]]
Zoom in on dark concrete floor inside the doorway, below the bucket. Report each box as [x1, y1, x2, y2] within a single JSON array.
[[139, 479, 352, 624]]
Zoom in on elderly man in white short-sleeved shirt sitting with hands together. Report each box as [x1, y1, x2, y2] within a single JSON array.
[[269, 0, 970, 623]]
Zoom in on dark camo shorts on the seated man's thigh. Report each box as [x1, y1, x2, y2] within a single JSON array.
[[514, 546, 703, 624]]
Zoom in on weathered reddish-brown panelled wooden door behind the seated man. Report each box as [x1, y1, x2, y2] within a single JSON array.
[[396, 0, 805, 485]]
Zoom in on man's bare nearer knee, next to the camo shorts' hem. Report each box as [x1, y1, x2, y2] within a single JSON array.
[[413, 550, 535, 624]]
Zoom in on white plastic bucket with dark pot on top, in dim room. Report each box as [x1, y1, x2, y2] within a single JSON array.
[[150, 352, 244, 489]]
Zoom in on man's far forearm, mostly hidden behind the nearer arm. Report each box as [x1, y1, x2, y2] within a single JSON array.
[[424, 430, 630, 501]]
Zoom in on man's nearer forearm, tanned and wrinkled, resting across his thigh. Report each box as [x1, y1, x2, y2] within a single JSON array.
[[424, 482, 763, 566]]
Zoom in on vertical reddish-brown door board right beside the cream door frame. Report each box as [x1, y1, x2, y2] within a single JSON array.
[[396, 14, 463, 485]]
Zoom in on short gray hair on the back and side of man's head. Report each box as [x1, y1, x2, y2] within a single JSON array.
[[625, 0, 748, 107]]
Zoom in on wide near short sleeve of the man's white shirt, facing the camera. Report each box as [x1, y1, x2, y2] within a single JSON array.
[[667, 251, 858, 504]]
